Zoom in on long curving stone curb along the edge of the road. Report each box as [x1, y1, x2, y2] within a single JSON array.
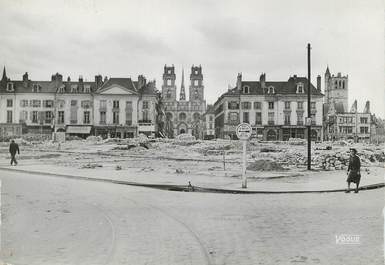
[[0, 167, 385, 194]]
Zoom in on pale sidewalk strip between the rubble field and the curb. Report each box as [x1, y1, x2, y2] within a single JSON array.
[[0, 161, 385, 192]]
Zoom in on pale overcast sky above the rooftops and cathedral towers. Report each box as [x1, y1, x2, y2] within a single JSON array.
[[0, 0, 385, 117]]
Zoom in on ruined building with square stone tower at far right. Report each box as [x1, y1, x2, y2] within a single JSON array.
[[323, 67, 373, 141]]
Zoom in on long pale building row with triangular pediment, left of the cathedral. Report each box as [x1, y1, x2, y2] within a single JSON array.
[[0, 68, 157, 138]]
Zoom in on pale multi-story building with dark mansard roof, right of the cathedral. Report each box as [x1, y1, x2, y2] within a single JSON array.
[[214, 74, 324, 141]]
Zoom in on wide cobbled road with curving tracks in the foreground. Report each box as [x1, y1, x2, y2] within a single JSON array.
[[0, 171, 384, 265]]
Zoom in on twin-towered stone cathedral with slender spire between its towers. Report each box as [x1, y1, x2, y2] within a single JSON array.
[[162, 65, 206, 138]]
